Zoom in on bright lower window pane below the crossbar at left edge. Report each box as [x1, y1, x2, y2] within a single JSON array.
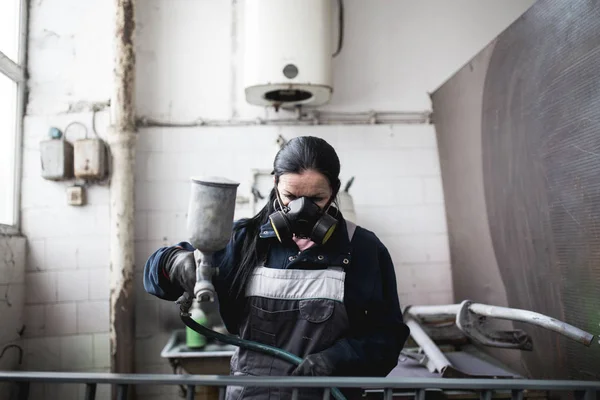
[[0, 73, 17, 225]]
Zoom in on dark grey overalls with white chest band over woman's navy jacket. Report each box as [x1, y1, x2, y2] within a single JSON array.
[[226, 222, 355, 400]]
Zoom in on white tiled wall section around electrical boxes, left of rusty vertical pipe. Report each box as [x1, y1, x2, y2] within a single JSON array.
[[22, 109, 109, 400]]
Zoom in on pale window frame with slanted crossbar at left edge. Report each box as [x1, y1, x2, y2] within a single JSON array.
[[0, 0, 29, 235]]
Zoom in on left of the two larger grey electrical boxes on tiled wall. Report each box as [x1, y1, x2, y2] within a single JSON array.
[[40, 128, 73, 181]]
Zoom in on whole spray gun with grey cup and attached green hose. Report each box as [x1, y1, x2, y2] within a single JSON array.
[[177, 178, 345, 400]]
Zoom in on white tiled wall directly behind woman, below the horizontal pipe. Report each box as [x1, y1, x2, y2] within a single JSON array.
[[136, 125, 452, 310]]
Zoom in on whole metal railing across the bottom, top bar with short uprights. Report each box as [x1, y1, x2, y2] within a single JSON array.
[[0, 371, 600, 400]]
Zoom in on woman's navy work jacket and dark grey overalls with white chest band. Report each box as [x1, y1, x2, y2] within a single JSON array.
[[144, 219, 408, 400]]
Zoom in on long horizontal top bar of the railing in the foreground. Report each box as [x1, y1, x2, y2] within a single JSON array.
[[0, 371, 600, 392]]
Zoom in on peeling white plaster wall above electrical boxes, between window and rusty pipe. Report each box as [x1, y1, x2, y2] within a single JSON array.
[[27, 0, 114, 115]]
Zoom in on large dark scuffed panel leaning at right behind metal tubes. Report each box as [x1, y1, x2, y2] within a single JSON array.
[[432, 0, 600, 379]]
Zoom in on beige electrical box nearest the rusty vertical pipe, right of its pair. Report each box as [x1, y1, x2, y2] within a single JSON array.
[[74, 139, 107, 180]]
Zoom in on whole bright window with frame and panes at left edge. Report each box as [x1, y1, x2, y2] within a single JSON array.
[[0, 0, 27, 233]]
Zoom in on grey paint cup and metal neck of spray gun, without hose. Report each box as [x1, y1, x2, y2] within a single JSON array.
[[187, 177, 239, 302]]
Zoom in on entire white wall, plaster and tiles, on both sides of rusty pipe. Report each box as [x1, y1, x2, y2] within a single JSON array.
[[17, 0, 532, 399]]
